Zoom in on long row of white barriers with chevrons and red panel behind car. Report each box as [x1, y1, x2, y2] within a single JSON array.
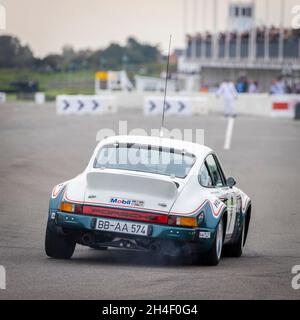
[[45, 92, 300, 118]]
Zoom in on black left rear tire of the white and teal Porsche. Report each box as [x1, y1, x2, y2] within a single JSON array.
[[45, 221, 76, 259]]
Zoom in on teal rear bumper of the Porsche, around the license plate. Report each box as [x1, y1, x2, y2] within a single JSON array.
[[49, 210, 215, 251]]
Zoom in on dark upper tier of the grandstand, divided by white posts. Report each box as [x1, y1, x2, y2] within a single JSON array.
[[186, 27, 300, 62]]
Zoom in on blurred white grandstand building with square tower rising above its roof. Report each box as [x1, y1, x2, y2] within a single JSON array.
[[178, 2, 300, 91]]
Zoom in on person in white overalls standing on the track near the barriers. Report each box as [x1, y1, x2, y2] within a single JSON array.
[[217, 80, 238, 117]]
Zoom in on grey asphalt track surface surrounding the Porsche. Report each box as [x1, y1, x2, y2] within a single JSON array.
[[0, 103, 300, 299]]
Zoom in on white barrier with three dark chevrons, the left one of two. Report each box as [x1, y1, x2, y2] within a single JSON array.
[[56, 95, 117, 115]]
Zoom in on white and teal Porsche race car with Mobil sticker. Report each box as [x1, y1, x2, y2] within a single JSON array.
[[45, 136, 251, 265]]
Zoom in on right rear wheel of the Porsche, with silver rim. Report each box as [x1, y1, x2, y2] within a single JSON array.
[[201, 219, 224, 266]]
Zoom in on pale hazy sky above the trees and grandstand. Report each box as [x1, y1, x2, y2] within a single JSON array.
[[0, 0, 300, 57]]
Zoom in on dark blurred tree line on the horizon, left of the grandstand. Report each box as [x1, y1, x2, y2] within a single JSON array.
[[0, 35, 162, 72]]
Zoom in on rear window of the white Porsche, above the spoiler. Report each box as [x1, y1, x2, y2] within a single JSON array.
[[94, 143, 196, 178]]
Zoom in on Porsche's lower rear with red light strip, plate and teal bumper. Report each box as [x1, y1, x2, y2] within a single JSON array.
[[51, 202, 212, 255]]
